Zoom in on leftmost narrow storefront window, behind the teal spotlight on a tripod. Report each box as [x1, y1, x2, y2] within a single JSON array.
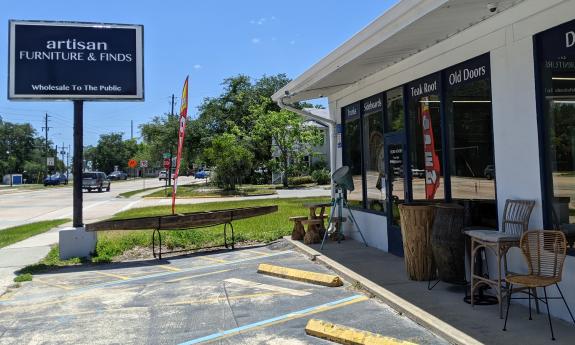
[[342, 103, 363, 207]]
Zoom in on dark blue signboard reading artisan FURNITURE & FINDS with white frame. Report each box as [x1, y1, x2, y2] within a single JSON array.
[[8, 20, 144, 100]]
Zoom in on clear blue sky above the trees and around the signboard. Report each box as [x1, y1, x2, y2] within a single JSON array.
[[0, 0, 396, 146]]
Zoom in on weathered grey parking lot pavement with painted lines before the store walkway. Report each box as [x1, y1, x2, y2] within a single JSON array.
[[0, 243, 447, 345]]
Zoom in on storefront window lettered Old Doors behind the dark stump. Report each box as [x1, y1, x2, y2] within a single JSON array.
[[444, 55, 495, 199]]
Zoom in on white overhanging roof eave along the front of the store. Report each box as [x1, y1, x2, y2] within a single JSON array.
[[272, 0, 523, 103]]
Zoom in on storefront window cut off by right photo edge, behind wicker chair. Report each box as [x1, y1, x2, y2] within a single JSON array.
[[535, 21, 575, 253]]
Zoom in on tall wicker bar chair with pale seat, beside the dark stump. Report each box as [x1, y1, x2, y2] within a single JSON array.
[[464, 199, 539, 319]]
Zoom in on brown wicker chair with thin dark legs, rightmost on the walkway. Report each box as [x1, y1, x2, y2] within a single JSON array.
[[503, 230, 575, 340]]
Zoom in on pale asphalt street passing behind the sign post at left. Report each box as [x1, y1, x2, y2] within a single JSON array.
[[0, 176, 194, 230]]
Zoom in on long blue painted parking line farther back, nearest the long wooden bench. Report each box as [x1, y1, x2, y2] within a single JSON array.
[[0, 250, 293, 305]]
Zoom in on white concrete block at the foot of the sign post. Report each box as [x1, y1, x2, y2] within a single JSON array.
[[59, 227, 96, 260]]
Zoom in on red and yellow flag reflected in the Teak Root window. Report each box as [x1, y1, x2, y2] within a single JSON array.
[[421, 97, 441, 200]]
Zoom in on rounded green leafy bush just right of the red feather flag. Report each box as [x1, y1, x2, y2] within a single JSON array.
[[204, 133, 254, 190]]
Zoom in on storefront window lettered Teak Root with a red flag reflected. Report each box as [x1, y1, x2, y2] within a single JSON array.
[[408, 75, 444, 200]]
